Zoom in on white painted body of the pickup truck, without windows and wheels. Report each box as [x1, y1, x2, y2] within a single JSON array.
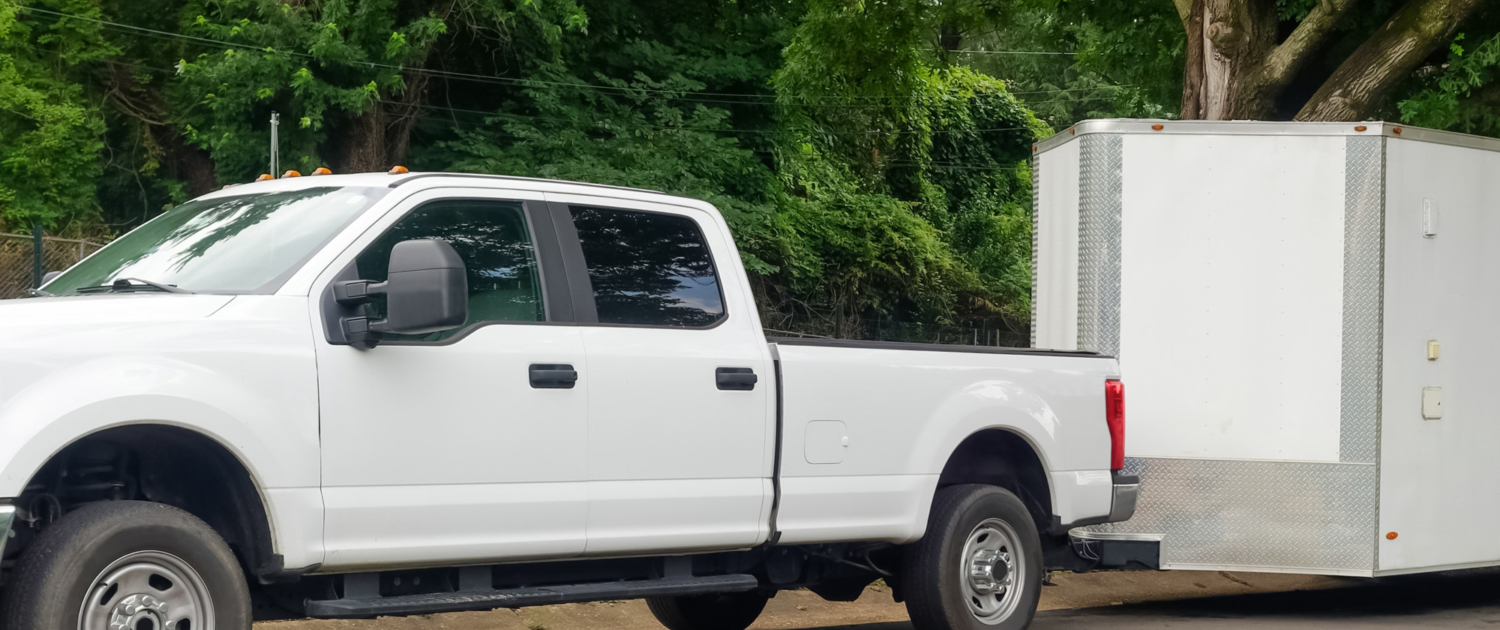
[[0, 174, 1118, 573]]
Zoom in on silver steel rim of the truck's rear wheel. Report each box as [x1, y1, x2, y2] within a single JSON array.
[[959, 519, 1028, 626]]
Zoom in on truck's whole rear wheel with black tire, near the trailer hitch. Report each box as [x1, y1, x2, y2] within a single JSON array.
[[902, 485, 1044, 630]]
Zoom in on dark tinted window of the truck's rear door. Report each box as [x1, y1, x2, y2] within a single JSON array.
[[573, 207, 725, 327]]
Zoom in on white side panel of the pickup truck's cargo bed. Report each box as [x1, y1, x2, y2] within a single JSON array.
[[777, 344, 1113, 543]]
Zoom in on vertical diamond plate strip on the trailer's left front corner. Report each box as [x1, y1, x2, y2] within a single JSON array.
[[1079, 134, 1124, 356]]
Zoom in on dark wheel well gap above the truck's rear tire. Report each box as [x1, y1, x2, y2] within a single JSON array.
[[938, 429, 1053, 531]]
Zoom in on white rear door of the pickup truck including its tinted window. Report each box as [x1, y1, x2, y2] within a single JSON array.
[[548, 194, 774, 555]]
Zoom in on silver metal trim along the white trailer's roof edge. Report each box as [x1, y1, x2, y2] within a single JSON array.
[[1037, 119, 1500, 155]]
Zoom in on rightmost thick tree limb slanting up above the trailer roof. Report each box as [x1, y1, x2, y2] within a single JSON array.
[[1296, 0, 1484, 120]]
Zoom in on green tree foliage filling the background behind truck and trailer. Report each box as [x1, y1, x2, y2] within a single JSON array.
[[17, 0, 1500, 341]]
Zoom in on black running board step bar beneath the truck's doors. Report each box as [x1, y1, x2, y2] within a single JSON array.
[[308, 575, 761, 620]]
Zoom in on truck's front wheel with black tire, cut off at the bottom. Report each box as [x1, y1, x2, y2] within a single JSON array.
[[0, 501, 251, 630]]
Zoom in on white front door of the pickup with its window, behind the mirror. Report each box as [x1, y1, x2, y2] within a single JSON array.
[[318, 189, 588, 569]]
